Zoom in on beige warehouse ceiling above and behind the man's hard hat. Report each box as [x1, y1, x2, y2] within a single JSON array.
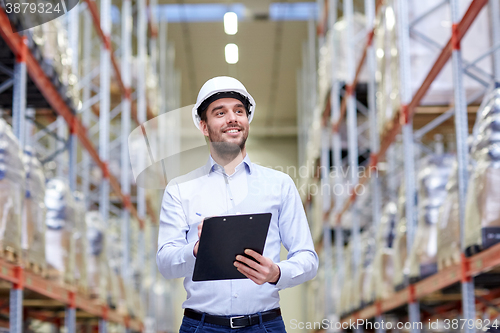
[[159, 0, 312, 135]]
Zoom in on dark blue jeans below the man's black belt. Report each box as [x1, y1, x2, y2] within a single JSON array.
[[179, 316, 286, 333]]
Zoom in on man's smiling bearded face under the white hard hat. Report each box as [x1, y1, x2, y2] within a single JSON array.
[[200, 98, 249, 151]]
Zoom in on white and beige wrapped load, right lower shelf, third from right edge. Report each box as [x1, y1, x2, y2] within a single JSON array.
[[408, 154, 454, 283]]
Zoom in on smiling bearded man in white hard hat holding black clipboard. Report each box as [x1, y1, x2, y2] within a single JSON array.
[[157, 77, 318, 332]]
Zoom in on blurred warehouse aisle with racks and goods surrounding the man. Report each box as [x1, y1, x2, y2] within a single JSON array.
[[0, 0, 500, 333]]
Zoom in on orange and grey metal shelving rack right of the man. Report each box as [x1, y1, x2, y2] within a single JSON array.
[[299, 0, 500, 326]]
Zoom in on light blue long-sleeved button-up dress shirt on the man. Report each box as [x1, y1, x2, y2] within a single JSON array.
[[156, 154, 318, 315]]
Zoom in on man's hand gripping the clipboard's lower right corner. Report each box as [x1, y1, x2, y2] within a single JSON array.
[[234, 249, 281, 285]]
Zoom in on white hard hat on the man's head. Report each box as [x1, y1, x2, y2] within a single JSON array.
[[192, 76, 255, 129]]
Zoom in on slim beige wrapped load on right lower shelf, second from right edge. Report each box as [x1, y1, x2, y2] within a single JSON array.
[[437, 162, 461, 270]]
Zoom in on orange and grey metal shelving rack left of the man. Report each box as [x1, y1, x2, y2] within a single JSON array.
[[0, 0, 179, 333]]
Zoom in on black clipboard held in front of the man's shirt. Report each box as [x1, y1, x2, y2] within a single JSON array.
[[193, 213, 272, 281]]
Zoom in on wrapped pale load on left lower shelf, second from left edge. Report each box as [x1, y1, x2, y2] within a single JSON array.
[[21, 147, 47, 275]]
